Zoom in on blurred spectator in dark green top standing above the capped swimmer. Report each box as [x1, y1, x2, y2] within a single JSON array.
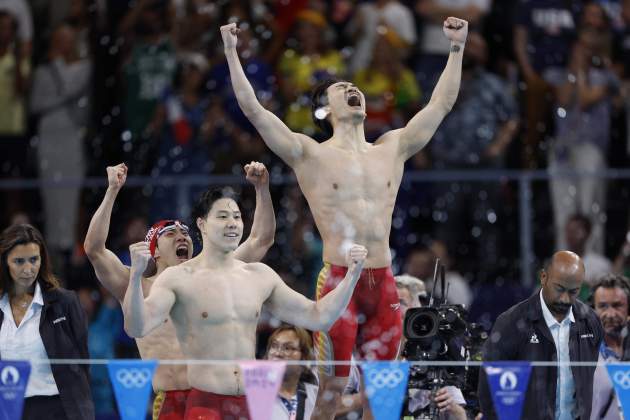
[[120, 0, 177, 174]]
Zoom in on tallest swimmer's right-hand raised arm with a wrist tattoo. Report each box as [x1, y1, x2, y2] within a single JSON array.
[[390, 17, 468, 160]]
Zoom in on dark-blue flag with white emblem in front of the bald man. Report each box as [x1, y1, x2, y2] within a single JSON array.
[[483, 362, 532, 420]]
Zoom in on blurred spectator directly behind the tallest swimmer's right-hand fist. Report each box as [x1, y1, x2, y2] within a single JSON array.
[[415, 0, 492, 101]]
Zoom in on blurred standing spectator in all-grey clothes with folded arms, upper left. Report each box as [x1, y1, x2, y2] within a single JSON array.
[[31, 25, 91, 272]]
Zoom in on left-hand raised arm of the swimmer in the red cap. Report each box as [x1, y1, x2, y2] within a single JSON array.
[[83, 163, 129, 302]]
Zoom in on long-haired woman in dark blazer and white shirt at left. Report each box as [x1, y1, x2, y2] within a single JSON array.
[[0, 224, 94, 420]]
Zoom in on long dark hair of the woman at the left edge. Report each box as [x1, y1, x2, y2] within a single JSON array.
[[0, 224, 59, 294]]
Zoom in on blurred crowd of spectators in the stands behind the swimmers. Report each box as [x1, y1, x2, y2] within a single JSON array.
[[0, 0, 630, 416]]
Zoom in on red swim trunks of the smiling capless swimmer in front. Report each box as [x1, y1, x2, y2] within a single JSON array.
[[184, 388, 249, 420]]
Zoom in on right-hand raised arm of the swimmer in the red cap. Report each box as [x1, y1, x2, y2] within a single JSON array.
[[234, 162, 276, 262]]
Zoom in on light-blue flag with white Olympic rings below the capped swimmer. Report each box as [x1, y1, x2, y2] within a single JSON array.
[[107, 360, 157, 420]]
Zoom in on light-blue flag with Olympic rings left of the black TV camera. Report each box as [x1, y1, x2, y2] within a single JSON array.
[[363, 362, 409, 420]]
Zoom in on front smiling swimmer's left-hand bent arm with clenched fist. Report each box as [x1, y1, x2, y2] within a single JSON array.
[[123, 242, 175, 338]]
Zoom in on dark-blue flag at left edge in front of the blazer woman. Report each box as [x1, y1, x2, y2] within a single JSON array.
[[0, 360, 31, 420]]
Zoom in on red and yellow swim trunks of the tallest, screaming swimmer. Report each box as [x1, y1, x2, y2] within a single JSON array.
[[314, 263, 402, 376]]
